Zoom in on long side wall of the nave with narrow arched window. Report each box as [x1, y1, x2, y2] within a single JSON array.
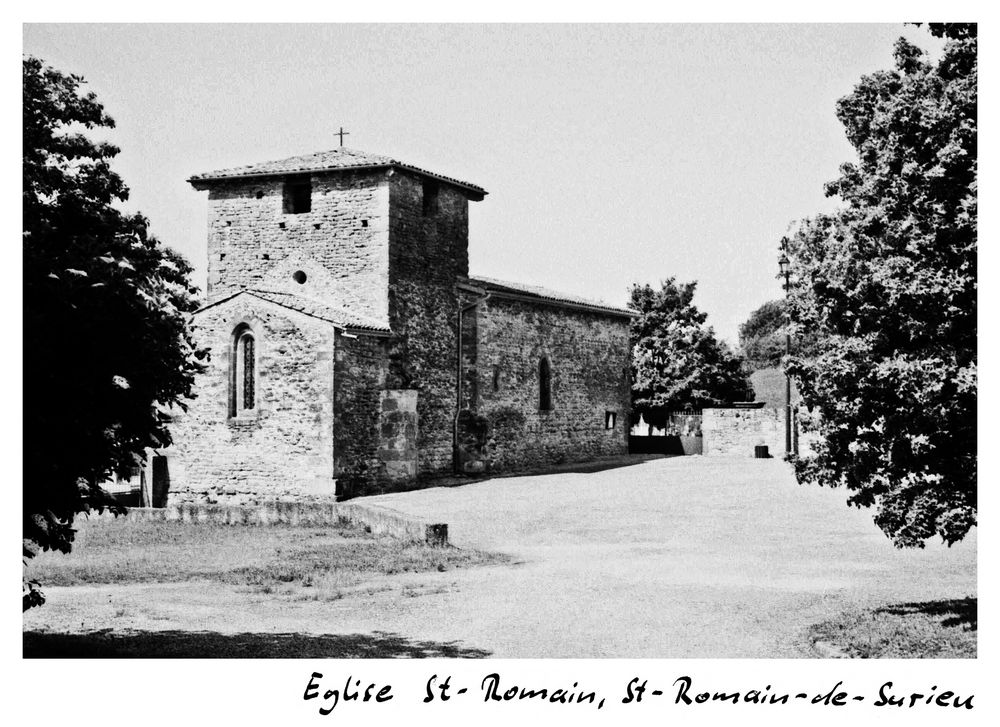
[[476, 298, 630, 471]]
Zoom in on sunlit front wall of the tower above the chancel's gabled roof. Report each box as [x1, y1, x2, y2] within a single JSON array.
[[208, 170, 389, 320]]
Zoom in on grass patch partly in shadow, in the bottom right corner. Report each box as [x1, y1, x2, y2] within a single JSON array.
[[812, 598, 978, 659]]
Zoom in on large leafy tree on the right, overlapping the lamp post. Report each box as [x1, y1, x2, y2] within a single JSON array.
[[788, 24, 977, 547]]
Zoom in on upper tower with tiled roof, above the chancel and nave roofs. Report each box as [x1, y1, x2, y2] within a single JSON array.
[[188, 148, 486, 321]]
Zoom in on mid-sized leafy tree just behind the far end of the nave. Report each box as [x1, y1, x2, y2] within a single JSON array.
[[630, 278, 753, 416]]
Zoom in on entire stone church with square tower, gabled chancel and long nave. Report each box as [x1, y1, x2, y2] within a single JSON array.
[[164, 148, 634, 503]]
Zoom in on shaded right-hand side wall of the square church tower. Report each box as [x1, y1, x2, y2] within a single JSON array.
[[386, 172, 469, 477]]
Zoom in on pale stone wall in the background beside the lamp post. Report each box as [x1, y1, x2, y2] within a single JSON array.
[[701, 408, 785, 457]]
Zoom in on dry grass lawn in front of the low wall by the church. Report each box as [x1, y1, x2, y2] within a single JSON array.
[[28, 519, 506, 600]]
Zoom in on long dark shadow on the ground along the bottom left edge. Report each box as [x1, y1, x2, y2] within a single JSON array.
[[23, 629, 491, 659]]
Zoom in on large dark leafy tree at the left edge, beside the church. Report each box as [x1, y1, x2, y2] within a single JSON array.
[[22, 57, 205, 609]]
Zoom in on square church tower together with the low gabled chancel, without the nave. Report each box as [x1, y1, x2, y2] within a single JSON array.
[[171, 148, 486, 501]]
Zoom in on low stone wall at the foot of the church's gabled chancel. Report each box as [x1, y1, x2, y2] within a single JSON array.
[[105, 501, 448, 545]]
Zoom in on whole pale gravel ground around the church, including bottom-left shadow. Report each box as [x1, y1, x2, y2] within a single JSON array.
[[24, 457, 976, 658]]
